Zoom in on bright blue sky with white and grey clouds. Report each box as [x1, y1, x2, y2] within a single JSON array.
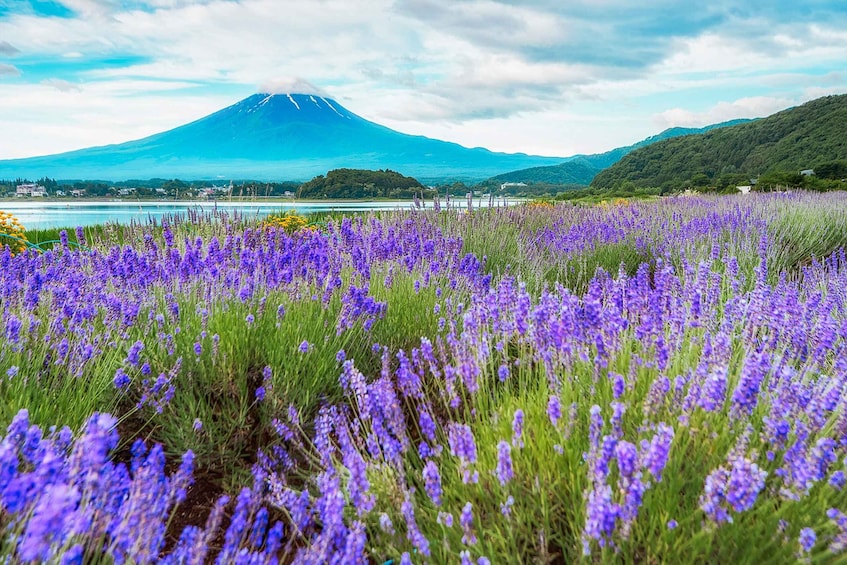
[[0, 0, 847, 159]]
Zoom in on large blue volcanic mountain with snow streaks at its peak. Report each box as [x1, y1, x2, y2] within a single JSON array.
[[0, 94, 563, 181]]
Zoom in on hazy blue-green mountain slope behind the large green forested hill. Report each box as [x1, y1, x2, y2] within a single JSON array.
[[489, 120, 750, 185]]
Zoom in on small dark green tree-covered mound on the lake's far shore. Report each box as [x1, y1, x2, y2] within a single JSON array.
[[297, 169, 427, 198]]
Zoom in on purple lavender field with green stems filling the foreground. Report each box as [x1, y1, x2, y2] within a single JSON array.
[[0, 193, 847, 565]]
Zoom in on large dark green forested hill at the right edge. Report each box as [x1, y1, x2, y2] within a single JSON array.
[[592, 95, 847, 189]]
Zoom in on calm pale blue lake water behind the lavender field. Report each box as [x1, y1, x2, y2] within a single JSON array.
[[0, 198, 520, 230]]
